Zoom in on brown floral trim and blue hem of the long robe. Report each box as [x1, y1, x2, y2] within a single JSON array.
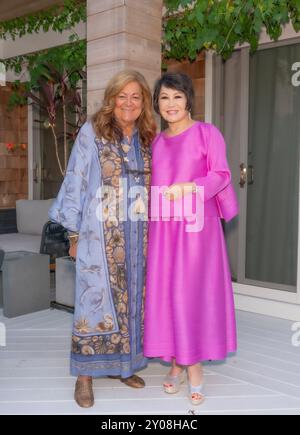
[[71, 134, 151, 364]]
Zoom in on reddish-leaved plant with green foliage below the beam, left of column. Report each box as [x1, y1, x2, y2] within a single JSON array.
[[4, 38, 86, 175]]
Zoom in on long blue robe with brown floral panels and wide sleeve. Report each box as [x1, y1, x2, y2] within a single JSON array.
[[49, 122, 150, 378]]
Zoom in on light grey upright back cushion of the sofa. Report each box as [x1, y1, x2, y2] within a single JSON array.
[[16, 199, 53, 235]]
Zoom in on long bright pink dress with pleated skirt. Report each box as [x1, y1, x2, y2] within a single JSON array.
[[144, 122, 237, 365]]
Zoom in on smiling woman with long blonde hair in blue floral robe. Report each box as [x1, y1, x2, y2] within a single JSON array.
[[50, 71, 156, 407]]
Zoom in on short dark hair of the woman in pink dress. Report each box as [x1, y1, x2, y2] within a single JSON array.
[[153, 72, 195, 114]]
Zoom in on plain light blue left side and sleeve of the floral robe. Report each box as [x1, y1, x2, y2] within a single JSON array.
[[49, 122, 119, 340]]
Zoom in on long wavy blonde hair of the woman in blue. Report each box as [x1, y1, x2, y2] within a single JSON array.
[[92, 70, 156, 146]]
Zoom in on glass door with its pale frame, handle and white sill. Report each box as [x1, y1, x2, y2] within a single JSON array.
[[215, 39, 300, 303]]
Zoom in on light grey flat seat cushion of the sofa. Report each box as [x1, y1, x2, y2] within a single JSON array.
[[0, 233, 41, 253]]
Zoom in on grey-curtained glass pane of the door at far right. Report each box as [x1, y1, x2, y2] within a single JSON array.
[[245, 44, 300, 293]]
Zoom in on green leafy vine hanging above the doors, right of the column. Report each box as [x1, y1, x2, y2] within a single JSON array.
[[163, 0, 300, 60]]
